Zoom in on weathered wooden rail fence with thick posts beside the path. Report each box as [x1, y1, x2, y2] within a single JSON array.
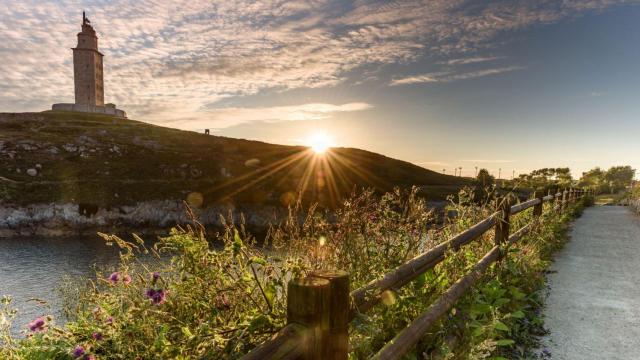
[[243, 189, 590, 360]]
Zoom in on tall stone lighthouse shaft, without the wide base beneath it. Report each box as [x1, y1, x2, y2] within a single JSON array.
[[73, 11, 104, 106]]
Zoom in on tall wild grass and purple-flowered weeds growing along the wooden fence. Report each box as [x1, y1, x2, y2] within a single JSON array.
[[0, 190, 579, 359]]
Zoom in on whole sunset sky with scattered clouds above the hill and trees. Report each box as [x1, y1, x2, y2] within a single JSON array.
[[0, 0, 640, 178]]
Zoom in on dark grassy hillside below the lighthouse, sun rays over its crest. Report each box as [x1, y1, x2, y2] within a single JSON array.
[[0, 111, 467, 206]]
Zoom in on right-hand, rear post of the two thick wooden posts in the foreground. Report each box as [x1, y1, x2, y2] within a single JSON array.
[[311, 270, 350, 360]]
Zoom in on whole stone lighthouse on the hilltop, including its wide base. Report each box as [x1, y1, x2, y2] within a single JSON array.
[[51, 12, 127, 118]]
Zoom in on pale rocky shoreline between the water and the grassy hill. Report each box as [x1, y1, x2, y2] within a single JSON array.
[[0, 200, 287, 239]]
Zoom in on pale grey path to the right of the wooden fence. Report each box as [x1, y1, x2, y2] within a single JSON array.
[[543, 206, 640, 360]]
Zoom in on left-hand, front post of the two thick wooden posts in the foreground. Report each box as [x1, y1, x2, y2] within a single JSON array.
[[287, 276, 331, 360]]
